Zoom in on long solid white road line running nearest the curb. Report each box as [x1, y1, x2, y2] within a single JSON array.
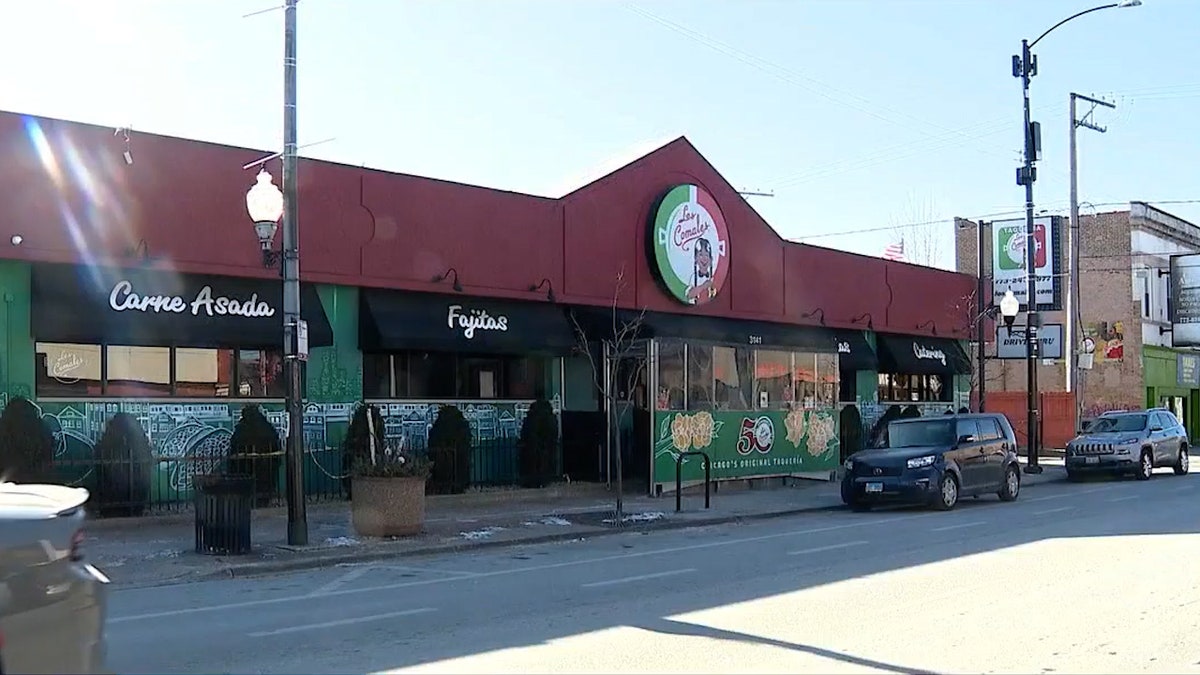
[[106, 513, 942, 625]]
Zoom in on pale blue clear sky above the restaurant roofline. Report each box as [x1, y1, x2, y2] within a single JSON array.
[[0, 0, 1200, 267]]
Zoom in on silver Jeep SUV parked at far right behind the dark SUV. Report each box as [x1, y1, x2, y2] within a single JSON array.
[[1067, 408, 1188, 480]]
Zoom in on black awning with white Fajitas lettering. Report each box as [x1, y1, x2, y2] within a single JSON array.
[[359, 288, 578, 354]]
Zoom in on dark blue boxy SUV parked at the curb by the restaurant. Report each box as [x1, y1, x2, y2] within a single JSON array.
[[841, 413, 1021, 510]]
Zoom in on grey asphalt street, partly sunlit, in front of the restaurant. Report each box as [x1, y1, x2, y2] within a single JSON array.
[[109, 472, 1200, 674]]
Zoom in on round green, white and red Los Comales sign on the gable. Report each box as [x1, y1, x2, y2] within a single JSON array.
[[650, 185, 730, 305]]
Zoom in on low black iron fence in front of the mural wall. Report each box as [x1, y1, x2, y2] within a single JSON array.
[[54, 429, 562, 518]]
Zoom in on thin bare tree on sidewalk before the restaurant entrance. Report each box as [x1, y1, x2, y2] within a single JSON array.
[[571, 267, 653, 527]]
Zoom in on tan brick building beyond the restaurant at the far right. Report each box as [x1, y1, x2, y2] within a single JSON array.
[[955, 202, 1200, 447]]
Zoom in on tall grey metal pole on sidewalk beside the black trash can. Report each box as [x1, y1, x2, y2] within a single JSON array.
[[280, 0, 308, 546]]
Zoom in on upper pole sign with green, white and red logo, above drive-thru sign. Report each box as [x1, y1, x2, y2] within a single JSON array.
[[991, 216, 1062, 311]]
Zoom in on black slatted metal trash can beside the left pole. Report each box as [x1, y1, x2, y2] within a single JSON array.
[[193, 474, 254, 555]]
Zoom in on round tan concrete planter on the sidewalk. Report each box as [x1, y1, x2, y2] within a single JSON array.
[[350, 476, 425, 537]]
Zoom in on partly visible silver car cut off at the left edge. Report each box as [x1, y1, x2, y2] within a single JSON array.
[[0, 483, 109, 675]]
